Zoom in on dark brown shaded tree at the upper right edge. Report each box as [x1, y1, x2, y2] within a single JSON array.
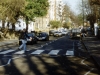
[[87, 0, 100, 28]]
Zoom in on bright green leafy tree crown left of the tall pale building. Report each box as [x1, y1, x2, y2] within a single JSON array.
[[23, 0, 49, 20]]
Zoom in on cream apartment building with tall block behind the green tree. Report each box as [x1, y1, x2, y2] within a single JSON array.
[[34, 0, 64, 31]]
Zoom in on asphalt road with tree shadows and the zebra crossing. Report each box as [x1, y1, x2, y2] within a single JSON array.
[[0, 36, 99, 75]]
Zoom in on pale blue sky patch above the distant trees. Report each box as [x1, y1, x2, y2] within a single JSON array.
[[63, 0, 81, 14]]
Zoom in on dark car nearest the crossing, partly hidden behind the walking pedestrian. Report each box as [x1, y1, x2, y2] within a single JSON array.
[[19, 33, 38, 45]]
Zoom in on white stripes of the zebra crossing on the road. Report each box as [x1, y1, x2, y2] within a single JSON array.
[[0, 49, 74, 56]]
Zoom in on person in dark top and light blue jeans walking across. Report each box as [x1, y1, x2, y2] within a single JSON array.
[[18, 29, 29, 53]]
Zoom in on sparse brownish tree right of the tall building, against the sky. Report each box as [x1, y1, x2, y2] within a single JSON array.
[[62, 4, 78, 27]]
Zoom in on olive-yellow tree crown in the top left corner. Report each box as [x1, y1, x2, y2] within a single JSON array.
[[0, 0, 25, 26]]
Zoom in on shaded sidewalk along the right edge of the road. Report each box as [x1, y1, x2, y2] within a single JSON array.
[[82, 36, 100, 69]]
